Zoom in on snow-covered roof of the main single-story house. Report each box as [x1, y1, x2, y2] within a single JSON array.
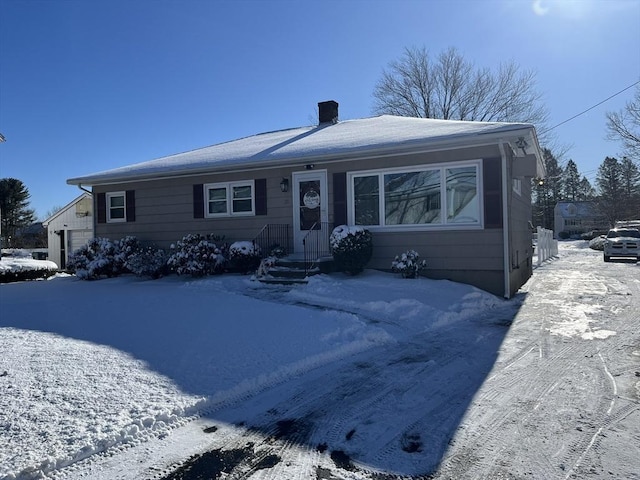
[[67, 115, 540, 185]]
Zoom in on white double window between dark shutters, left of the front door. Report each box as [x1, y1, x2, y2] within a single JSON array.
[[204, 182, 255, 217]]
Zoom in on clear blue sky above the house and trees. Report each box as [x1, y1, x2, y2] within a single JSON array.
[[0, 0, 640, 219]]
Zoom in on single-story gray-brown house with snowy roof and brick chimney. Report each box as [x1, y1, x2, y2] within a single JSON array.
[[67, 101, 545, 297]]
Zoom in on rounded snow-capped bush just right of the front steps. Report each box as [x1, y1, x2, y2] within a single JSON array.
[[329, 225, 373, 275]]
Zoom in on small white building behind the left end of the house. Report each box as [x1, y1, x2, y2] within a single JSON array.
[[43, 192, 94, 270]]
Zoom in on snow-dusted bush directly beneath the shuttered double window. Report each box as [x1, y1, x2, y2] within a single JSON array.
[[167, 234, 226, 277]]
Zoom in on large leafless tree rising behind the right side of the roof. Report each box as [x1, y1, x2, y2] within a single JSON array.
[[373, 47, 549, 142]]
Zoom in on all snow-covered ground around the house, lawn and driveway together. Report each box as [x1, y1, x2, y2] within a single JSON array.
[[0, 242, 640, 480]]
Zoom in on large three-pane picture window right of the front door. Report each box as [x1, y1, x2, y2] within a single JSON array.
[[349, 161, 480, 229]]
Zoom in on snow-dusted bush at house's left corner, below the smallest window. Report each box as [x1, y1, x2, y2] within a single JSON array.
[[67, 237, 124, 280]]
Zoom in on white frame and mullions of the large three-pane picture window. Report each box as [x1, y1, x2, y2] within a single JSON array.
[[347, 159, 484, 232]]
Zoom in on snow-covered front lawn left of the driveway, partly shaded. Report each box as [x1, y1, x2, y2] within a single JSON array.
[[0, 262, 502, 478]]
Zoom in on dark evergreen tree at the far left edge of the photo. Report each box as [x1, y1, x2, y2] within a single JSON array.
[[0, 178, 36, 248]]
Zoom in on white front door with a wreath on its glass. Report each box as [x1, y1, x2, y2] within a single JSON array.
[[292, 170, 329, 253]]
